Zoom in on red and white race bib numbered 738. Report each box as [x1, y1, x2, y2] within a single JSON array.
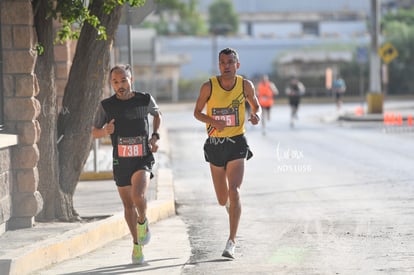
[[118, 136, 147, 158]]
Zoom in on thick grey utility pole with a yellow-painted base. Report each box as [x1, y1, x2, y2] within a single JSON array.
[[367, 0, 384, 113]]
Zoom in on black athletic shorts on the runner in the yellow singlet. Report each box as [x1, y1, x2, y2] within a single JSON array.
[[204, 135, 253, 167]]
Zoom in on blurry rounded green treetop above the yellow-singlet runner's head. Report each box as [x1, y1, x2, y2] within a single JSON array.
[[209, 0, 239, 34]]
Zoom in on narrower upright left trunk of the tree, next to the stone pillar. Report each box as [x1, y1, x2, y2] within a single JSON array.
[[32, 0, 63, 220]]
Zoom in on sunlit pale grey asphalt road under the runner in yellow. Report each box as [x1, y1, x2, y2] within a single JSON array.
[[165, 102, 414, 274]]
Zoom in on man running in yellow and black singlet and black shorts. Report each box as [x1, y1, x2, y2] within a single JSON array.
[[194, 48, 262, 258]]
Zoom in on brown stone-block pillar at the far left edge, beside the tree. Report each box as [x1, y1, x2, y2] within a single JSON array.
[[0, 0, 43, 233]]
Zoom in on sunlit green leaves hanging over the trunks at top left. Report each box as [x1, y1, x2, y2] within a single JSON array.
[[49, 0, 145, 43]]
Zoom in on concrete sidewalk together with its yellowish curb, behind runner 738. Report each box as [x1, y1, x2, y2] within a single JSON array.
[[0, 130, 175, 275]]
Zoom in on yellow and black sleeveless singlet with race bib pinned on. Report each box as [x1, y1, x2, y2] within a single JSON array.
[[206, 75, 245, 137]]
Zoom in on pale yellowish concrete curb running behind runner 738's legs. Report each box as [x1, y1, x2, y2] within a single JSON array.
[[0, 168, 175, 275]]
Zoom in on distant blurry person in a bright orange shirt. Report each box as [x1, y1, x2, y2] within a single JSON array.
[[257, 75, 279, 134]]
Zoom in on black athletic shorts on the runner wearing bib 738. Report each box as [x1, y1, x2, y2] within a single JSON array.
[[112, 153, 155, 187]]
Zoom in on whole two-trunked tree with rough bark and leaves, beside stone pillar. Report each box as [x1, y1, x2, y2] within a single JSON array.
[[32, 0, 152, 221]]
